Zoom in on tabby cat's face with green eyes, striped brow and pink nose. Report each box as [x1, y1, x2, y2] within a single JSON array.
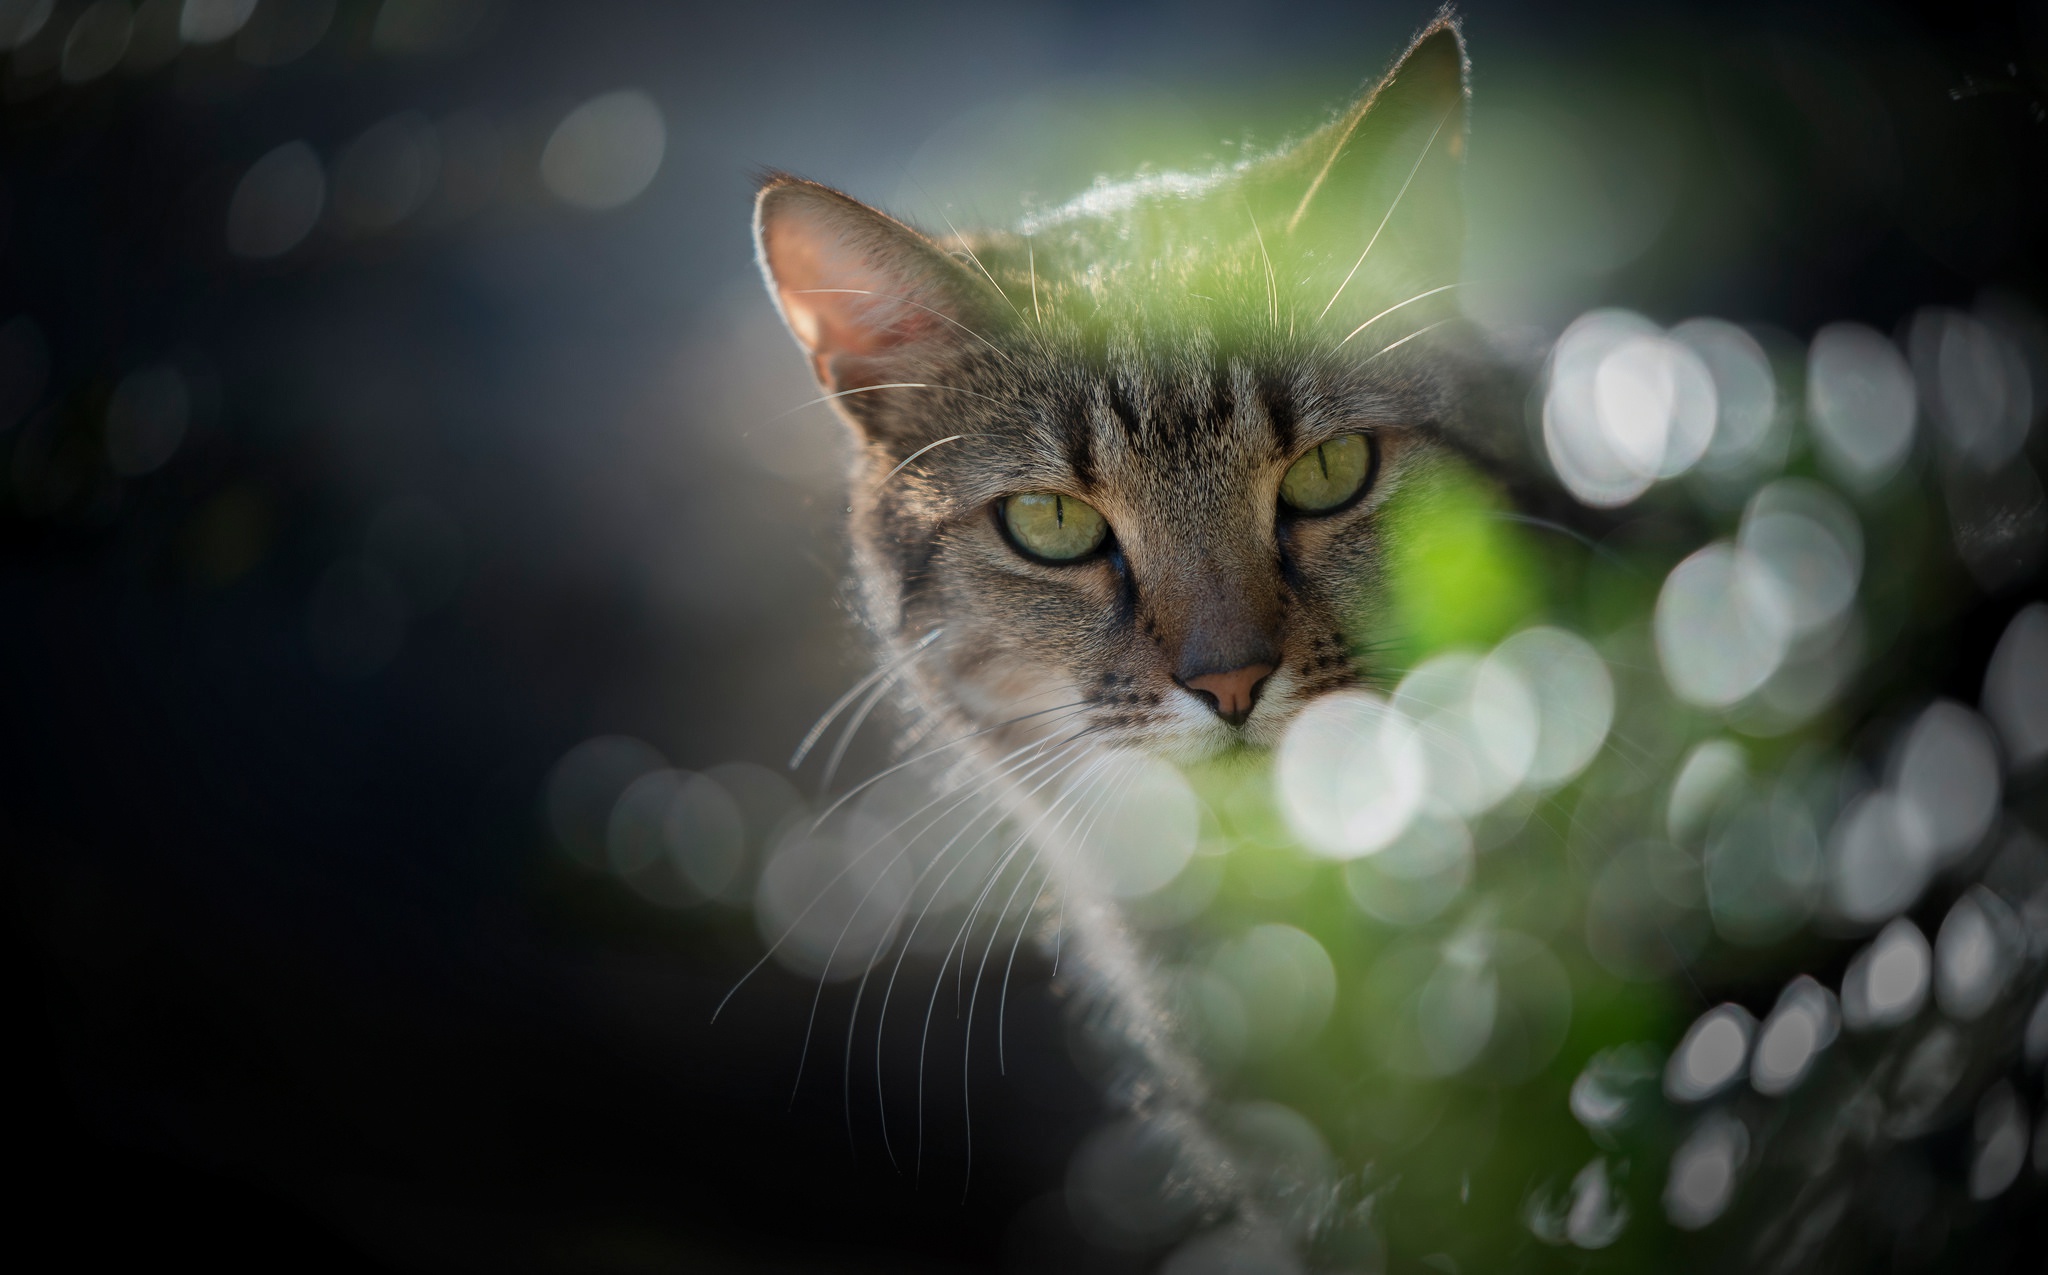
[[856, 334, 1438, 759]]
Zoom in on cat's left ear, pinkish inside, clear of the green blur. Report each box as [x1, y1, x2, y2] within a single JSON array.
[[754, 176, 993, 403]]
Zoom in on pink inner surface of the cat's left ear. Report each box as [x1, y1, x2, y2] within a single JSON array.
[[766, 213, 938, 391]]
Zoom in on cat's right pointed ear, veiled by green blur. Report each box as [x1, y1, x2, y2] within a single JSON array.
[[1247, 16, 1466, 319]]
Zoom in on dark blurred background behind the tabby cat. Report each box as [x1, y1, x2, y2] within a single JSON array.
[[12, 0, 2048, 1271]]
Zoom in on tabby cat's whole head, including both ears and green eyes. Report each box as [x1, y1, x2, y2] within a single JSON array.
[[756, 23, 1466, 759]]
